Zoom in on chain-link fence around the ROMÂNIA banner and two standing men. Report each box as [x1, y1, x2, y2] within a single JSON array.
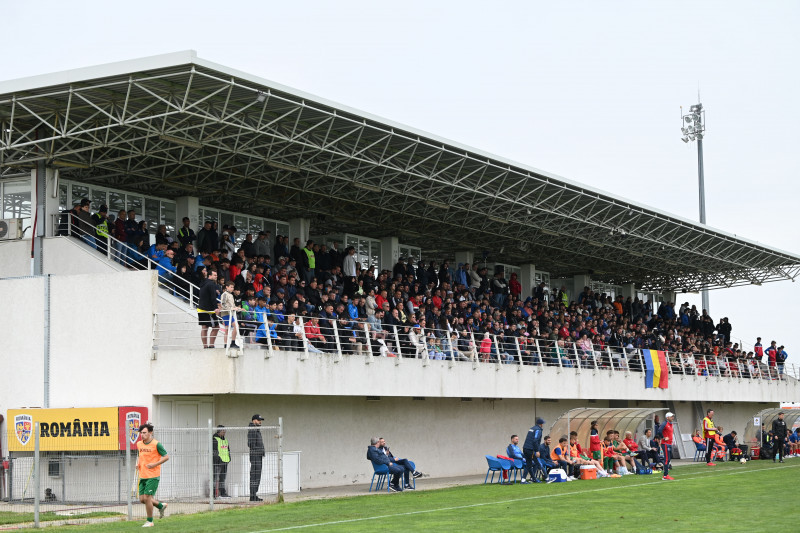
[[0, 419, 284, 529]]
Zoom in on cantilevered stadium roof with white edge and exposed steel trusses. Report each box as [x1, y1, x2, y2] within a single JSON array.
[[0, 51, 800, 291]]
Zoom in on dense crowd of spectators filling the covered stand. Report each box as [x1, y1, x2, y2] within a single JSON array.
[[62, 199, 787, 378]]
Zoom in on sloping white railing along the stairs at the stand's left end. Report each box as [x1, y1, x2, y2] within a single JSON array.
[[50, 213, 200, 310]]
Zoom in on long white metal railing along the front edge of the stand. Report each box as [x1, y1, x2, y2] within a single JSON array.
[[153, 313, 800, 381]]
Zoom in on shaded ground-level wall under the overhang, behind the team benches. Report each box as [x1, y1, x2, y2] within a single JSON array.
[[203, 394, 764, 488]]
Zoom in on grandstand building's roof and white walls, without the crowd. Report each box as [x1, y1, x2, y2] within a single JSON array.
[[0, 52, 800, 487]]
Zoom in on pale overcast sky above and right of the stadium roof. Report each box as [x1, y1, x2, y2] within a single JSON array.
[[6, 0, 800, 358]]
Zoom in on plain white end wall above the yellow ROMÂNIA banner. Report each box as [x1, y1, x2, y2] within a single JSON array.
[[0, 271, 156, 407]]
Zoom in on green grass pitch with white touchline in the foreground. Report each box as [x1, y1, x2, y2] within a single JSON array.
[[50, 460, 800, 533]]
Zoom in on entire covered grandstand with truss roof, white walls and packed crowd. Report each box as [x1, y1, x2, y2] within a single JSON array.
[[0, 48, 800, 487]]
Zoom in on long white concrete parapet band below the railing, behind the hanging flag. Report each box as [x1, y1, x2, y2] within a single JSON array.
[[148, 348, 800, 402]]
